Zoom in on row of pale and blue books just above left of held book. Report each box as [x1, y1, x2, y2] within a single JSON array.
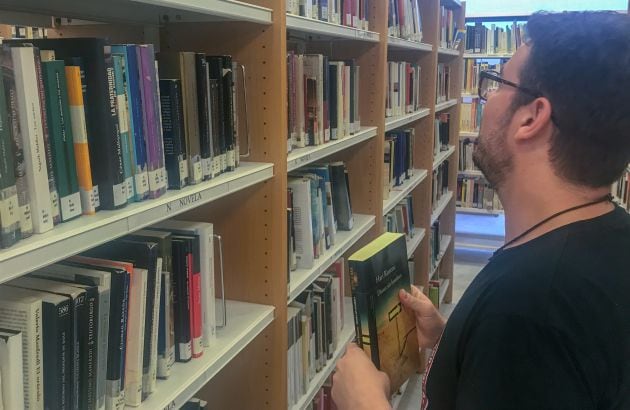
[[287, 162, 354, 271]]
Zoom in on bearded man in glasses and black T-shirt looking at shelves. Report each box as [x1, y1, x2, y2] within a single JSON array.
[[332, 13, 630, 410]]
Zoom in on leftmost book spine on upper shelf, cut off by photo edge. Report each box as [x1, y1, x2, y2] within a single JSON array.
[[0, 55, 20, 248]]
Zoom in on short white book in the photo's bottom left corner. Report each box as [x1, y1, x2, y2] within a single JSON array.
[[0, 328, 24, 410]]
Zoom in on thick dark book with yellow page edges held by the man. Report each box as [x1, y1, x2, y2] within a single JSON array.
[[348, 233, 420, 391]]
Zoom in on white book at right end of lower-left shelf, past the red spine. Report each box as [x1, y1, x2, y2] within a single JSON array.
[[153, 219, 217, 347]]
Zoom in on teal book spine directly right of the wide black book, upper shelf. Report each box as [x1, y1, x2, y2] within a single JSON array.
[[112, 55, 136, 202]]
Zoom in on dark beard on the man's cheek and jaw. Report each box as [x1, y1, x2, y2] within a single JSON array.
[[473, 121, 512, 189]]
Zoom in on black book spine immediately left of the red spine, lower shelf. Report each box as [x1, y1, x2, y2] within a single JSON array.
[[172, 239, 192, 362]]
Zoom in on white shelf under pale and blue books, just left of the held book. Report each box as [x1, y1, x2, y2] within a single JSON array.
[[287, 214, 376, 303]]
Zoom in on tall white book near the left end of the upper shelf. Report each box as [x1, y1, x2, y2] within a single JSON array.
[[11, 47, 53, 233]]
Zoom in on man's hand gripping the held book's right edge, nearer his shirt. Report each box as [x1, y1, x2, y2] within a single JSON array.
[[398, 285, 446, 349]]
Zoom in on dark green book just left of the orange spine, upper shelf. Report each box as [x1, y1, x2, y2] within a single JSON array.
[[42, 60, 83, 221]]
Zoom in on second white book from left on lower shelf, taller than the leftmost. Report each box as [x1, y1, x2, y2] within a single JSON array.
[[0, 287, 44, 410]]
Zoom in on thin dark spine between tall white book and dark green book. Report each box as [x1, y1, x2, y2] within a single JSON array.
[[33, 48, 65, 225]]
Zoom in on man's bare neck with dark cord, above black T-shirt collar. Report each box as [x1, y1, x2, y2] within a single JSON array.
[[499, 181, 613, 246]]
